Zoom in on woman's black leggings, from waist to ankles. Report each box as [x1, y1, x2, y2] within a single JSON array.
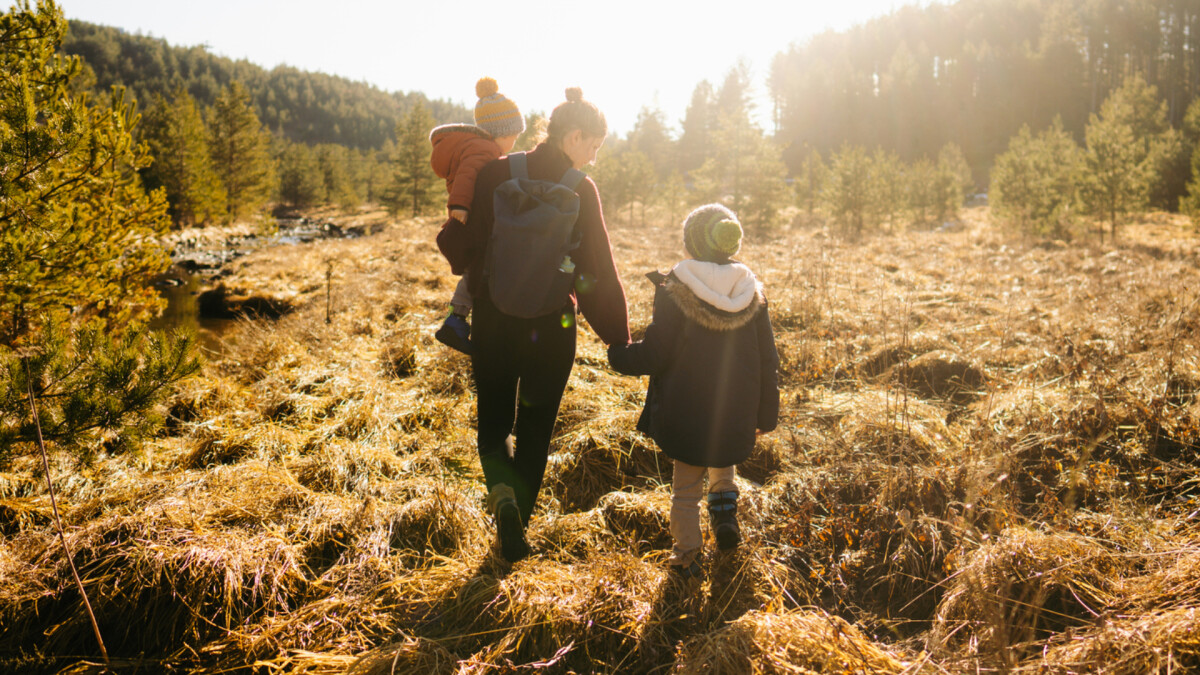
[[470, 293, 575, 524]]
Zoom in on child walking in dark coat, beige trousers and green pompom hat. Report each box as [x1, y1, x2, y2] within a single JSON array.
[[608, 204, 779, 578]]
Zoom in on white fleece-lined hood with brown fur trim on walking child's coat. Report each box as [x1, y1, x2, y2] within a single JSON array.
[[662, 259, 767, 330]]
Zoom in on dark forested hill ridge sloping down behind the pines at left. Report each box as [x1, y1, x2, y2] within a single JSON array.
[[61, 20, 472, 150]]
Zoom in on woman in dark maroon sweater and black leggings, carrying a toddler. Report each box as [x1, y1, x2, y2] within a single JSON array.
[[438, 88, 630, 562]]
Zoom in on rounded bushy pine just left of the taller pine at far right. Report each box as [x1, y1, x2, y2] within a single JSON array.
[[988, 119, 1084, 238]]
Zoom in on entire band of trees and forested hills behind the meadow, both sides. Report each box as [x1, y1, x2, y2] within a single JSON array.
[[64, 0, 1200, 238]]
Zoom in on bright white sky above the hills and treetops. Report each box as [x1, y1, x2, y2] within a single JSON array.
[[60, 0, 912, 133]]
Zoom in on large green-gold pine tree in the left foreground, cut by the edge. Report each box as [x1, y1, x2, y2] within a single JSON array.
[[0, 0, 197, 460]]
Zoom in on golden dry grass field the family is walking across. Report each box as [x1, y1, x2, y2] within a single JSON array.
[[0, 209, 1200, 675]]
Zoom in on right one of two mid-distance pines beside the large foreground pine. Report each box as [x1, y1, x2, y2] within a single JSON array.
[[211, 80, 275, 221]]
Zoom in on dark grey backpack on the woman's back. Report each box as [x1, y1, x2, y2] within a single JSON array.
[[484, 153, 583, 318]]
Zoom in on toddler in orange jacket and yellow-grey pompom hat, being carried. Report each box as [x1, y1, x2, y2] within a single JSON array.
[[430, 77, 526, 354]]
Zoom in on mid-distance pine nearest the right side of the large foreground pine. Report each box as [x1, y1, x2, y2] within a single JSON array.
[[143, 86, 226, 225]]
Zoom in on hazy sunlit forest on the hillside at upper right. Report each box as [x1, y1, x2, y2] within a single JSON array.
[[769, 0, 1200, 177]]
